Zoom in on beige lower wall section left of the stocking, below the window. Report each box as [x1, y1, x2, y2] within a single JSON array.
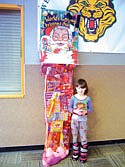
[[0, 65, 45, 147]]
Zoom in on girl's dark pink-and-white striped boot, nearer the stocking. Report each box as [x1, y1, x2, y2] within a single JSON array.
[[72, 143, 79, 161]]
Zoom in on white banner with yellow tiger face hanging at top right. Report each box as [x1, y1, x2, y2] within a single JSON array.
[[39, 0, 125, 53]]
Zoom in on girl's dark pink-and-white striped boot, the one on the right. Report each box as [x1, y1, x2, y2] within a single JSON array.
[[80, 144, 88, 163]]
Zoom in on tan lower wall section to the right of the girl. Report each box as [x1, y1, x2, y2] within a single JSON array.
[[74, 65, 125, 141]]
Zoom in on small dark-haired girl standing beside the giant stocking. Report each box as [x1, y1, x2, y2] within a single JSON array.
[[68, 79, 92, 163]]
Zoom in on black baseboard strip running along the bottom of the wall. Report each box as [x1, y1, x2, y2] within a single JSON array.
[[0, 139, 125, 152]]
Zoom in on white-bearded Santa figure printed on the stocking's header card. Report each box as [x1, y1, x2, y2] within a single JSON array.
[[41, 26, 74, 64]]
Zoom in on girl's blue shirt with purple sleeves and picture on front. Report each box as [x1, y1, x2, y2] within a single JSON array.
[[68, 95, 92, 121]]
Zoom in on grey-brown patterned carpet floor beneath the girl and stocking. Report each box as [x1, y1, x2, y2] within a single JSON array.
[[0, 143, 125, 167]]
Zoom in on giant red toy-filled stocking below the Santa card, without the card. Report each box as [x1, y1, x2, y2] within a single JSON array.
[[41, 64, 74, 166]]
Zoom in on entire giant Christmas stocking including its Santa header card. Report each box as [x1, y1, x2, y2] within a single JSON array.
[[40, 8, 78, 166]]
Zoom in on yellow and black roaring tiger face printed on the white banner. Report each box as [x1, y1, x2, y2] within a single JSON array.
[[67, 0, 116, 42]]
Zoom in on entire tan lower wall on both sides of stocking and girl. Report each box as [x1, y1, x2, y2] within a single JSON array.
[[0, 65, 125, 147]]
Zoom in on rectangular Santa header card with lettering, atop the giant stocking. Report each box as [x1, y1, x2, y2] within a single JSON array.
[[40, 9, 78, 64]]
